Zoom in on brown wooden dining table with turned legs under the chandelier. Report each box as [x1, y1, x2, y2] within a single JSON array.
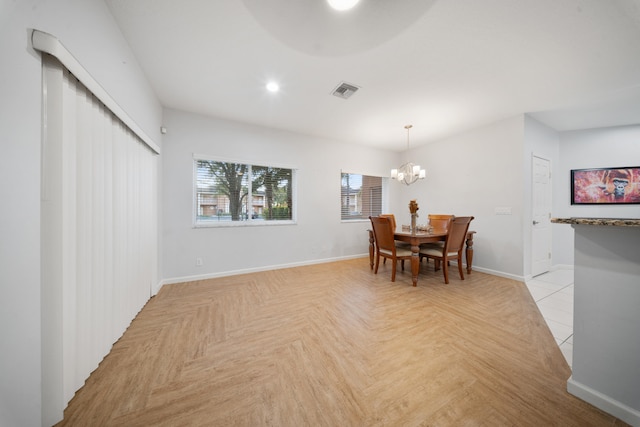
[[369, 229, 476, 286]]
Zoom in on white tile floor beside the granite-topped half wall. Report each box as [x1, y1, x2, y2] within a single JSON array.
[[526, 270, 573, 366]]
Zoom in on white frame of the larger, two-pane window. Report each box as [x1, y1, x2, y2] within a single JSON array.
[[191, 153, 298, 228]]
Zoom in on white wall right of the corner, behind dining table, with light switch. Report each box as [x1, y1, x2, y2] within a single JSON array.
[[392, 115, 529, 279]]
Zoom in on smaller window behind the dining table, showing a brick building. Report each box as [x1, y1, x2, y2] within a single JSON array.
[[340, 173, 385, 221]]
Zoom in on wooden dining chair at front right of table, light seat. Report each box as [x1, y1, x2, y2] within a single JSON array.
[[420, 216, 473, 283]]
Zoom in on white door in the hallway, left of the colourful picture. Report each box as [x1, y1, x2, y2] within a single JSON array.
[[531, 156, 551, 276]]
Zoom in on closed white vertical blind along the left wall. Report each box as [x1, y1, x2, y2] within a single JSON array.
[[42, 58, 158, 418]]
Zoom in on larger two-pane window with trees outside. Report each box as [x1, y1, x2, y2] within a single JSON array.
[[194, 158, 295, 226]]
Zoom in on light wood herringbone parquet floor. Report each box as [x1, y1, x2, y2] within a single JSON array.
[[58, 258, 626, 427]]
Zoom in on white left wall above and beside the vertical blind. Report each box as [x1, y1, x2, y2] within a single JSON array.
[[0, 0, 162, 426]]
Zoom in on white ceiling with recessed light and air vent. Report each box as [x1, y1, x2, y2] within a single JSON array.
[[105, 0, 640, 151]]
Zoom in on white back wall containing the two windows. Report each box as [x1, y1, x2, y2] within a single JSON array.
[[163, 110, 397, 283]]
